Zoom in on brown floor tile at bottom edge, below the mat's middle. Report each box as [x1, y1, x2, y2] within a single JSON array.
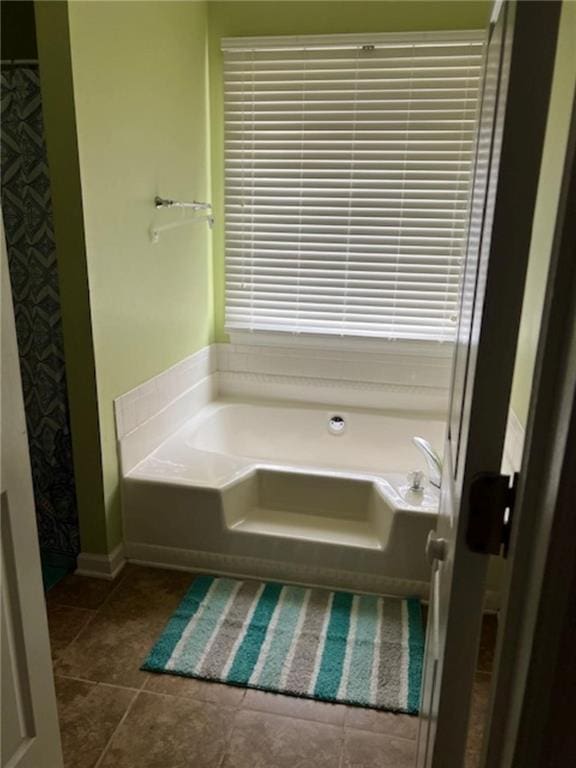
[[222, 709, 343, 768]]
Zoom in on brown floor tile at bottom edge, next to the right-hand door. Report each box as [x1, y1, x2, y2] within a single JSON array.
[[342, 730, 416, 768]]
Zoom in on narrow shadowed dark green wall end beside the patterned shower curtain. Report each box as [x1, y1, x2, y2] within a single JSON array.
[[35, 0, 108, 553]]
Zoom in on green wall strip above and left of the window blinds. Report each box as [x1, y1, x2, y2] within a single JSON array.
[[208, 0, 491, 341]]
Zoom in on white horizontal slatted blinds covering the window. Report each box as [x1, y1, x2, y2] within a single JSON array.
[[223, 33, 483, 340]]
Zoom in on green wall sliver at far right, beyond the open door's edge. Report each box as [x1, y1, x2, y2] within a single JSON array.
[[511, 0, 576, 426]]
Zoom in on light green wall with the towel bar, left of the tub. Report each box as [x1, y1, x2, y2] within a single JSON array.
[[68, 0, 213, 551]]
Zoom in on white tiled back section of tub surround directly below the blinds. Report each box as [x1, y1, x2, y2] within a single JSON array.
[[218, 334, 452, 412]]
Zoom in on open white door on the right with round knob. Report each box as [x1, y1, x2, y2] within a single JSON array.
[[417, 3, 555, 768]]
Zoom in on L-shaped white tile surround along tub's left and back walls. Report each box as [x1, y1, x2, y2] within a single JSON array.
[[114, 344, 451, 475]]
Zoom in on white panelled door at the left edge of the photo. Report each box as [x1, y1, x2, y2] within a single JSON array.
[[0, 219, 62, 768]]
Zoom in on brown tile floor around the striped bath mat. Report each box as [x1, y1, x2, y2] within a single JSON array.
[[47, 565, 495, 768]]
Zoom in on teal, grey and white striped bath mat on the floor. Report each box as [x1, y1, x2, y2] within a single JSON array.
[[142, 576, 424, 714]]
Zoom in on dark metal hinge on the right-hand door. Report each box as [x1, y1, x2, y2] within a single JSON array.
[[466, 472, 518, 557]]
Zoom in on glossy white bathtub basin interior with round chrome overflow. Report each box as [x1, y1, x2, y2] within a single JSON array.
[[130, 400, 445, 476]]
